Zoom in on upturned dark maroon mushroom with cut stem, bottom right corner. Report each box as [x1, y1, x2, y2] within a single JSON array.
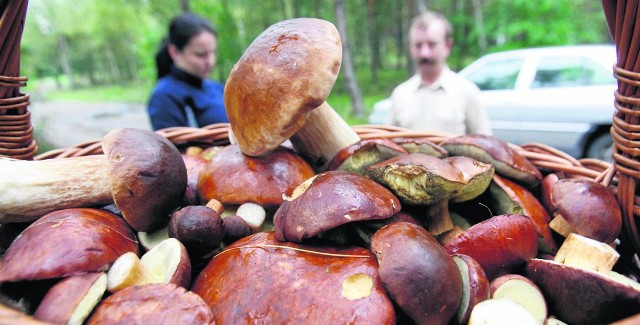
[[526, 233, 640, 324]]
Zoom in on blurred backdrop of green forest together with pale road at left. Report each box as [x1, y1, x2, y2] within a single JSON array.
[[21, 0, 613, 151]]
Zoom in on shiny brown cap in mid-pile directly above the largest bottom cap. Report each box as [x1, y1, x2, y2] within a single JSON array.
[[274, 171, 400, 242]]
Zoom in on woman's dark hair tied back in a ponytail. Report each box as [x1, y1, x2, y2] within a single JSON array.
[[156, 13, 218, 79]]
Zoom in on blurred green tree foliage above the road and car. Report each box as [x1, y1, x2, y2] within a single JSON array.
[[21, 0, 610, 109]]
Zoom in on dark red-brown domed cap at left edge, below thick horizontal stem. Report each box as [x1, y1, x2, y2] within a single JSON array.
[[0, 208, 139, 282]]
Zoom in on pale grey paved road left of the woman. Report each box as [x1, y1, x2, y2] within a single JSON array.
[[30, 102, 151, 148]]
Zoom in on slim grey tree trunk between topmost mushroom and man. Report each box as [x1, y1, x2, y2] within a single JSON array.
[[334, 0, 364, 117]]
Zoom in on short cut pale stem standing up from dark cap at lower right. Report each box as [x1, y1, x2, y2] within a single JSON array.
[[553, 233, 620, 274]]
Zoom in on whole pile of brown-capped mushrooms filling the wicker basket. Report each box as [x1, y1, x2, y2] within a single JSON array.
[[0, 18, 640, 324]]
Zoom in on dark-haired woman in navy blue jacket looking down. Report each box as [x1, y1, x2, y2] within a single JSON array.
[[147, 14, 229, 130]]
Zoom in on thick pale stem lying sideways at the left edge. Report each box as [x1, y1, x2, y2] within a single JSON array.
[[0, 155, 113, 223]]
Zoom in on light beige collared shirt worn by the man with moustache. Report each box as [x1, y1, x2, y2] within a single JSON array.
[[389, 67, 491, 135]]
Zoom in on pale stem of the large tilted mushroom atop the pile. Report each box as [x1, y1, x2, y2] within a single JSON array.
[[290, 102, 360, 172]]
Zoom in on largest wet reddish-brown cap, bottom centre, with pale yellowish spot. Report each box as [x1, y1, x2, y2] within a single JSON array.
[[191, 232, 395, 324]]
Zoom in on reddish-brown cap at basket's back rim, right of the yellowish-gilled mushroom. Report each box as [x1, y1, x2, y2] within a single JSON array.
[[440, 134, 542, 187]]
